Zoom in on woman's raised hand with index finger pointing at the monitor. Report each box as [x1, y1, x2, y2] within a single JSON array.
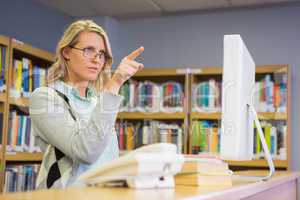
[[106, 47, 144, 94]]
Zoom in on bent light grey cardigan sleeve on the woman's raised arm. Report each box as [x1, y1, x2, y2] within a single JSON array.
[[29, 87, 123, 164]]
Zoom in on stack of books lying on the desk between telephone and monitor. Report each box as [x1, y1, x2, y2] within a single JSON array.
[[175, 155, 232, 186]]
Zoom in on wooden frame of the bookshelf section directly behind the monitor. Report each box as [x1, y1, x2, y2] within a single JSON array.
[[188, 65, 291, 170]]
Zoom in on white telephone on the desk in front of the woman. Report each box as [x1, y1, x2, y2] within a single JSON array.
[[77, 143, 184, 188]]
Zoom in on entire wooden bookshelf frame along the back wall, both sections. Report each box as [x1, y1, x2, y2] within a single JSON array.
[[118, 65, 290, 170]]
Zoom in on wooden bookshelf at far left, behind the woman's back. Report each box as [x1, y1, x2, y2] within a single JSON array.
[[0, 36, 54, 191]]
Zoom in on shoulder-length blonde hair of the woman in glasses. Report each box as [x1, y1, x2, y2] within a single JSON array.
[[47, 20, 113, 93]]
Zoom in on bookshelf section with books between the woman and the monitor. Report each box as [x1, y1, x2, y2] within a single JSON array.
[[116, 68, 190, 154]]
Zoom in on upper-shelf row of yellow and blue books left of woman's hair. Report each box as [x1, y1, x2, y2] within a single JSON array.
[[10, 58, 47, 97]]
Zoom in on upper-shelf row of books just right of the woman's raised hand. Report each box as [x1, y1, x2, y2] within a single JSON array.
[[120, 80, 184, 112]]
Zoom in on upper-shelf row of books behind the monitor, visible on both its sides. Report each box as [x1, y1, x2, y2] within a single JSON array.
[[192, 73, 287, 112]]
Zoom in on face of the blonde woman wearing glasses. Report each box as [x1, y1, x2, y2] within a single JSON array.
[[63, 32, 106, 82]]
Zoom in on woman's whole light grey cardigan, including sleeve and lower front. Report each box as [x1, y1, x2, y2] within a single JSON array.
[[29, 87, 122, 188]]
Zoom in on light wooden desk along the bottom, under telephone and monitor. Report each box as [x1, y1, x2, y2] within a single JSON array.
[[0, 171, 300, 200]]
